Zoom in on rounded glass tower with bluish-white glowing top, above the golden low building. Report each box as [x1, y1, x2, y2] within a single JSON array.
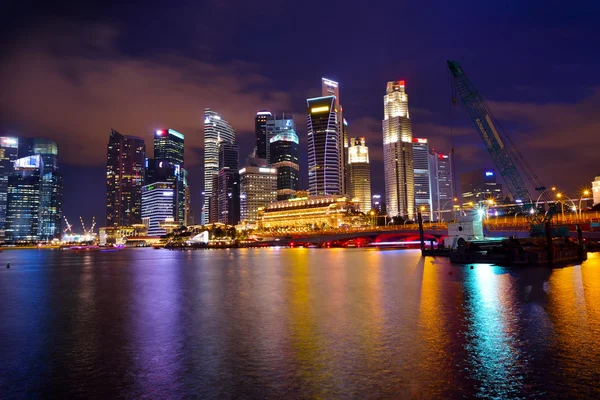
[[269, 117, 300, 200]]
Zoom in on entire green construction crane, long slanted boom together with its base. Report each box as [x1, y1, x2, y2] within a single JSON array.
[[448, 60, 553, 236]]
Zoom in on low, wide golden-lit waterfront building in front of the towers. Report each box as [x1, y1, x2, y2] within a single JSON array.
[[258, 195, 358, 231]]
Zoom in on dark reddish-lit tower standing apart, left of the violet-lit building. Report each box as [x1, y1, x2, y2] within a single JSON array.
[[106, 129, 146, 226]]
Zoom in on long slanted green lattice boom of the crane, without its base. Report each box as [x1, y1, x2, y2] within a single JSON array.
[[448, 61, 544, 204]]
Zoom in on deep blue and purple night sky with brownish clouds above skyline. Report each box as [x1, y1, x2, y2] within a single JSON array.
[[0, 0, 600, 228]]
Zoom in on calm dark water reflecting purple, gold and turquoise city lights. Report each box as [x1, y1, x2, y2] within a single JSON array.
[[0, 249, 600, 399]]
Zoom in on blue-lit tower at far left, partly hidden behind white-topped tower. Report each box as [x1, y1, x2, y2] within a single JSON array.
[[19, 138, 63, 241]]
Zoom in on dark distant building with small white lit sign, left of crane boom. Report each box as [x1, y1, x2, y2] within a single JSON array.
[[460, 168, 504, 206]]
